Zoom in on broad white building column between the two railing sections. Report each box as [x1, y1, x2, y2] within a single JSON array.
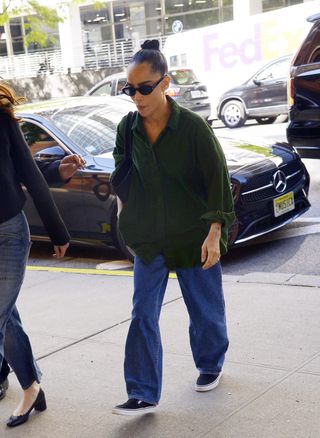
[[57, 2, 85, 73]]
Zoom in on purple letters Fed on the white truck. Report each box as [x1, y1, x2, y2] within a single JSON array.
[[203, 24, 262, 70]]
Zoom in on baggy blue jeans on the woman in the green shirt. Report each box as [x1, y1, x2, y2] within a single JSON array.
[[124, 255, 229, 404]]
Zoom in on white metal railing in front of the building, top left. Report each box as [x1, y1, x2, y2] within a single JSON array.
[[0, 36, 166, 79]]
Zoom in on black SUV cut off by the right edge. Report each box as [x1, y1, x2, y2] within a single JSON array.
[[287, 14, 320, 158]]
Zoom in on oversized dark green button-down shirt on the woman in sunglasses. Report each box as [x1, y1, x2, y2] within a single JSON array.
[[113, 97, 235, 269]]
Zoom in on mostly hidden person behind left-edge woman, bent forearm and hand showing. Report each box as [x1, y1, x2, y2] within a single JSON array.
[[0, 154, 85, 400]]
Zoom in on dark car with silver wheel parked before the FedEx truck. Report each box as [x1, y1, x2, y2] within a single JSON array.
[[217, 56, 291, 128]]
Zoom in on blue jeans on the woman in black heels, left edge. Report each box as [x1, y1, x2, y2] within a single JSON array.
[[0, 212, 41, 389]]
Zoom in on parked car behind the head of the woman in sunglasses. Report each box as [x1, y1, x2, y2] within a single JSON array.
[[86, 68, 211, 121]]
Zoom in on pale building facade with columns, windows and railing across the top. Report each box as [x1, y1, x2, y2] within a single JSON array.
[[0, 0, 312, 77]]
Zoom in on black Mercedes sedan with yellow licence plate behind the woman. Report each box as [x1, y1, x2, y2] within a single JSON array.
[[17, 97, 310, 258]]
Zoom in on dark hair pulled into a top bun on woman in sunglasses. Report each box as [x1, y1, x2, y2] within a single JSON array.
[[130, 40, 168, 76]]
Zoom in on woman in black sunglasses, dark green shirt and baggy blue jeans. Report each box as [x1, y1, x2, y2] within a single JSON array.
[[112, 40, 235, 415]]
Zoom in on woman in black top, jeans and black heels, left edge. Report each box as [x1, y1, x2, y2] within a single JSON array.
[[0, 84, 70, 427]]
